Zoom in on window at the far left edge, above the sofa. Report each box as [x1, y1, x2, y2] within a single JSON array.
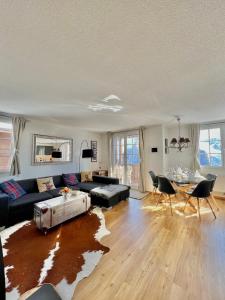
[[0, 117, 12, 173]]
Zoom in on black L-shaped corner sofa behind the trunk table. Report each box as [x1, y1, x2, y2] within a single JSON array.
[[0, 173, 129, 227]]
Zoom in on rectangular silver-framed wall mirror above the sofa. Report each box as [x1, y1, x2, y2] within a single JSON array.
[[32, 134, 73, 165]]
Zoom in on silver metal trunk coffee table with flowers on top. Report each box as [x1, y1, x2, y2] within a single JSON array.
[[34, 191, 91, 234]]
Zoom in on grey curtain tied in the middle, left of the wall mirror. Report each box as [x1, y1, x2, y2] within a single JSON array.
[[10, 117, 26, 175]]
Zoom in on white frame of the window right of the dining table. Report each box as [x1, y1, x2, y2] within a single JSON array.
[[198, 123, 225, 171]]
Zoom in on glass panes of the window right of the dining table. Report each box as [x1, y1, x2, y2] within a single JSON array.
[[199, 127, 223, 168]]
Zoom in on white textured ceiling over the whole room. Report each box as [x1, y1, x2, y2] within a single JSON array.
[[0, 0, 225, 131]]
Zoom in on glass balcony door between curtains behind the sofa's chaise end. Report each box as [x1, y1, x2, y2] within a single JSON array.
[[112, 132, 140, 189]]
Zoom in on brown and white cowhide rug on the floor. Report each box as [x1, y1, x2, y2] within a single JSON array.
[[0, 208, 110, 300]]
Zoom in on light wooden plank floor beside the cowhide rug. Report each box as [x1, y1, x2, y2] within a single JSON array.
[[73, 196, 225, 300]]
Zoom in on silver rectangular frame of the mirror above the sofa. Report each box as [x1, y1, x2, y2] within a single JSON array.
[[32, 133, 73, 166]]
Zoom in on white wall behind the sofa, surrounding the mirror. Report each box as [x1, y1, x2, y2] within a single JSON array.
[[1, 120, 105, 181]]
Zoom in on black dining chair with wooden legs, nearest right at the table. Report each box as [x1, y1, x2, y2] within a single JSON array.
[[184, 180, 216, 220]]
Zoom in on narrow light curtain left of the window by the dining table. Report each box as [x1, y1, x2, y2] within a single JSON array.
[[190, 124, 200, 171]]
